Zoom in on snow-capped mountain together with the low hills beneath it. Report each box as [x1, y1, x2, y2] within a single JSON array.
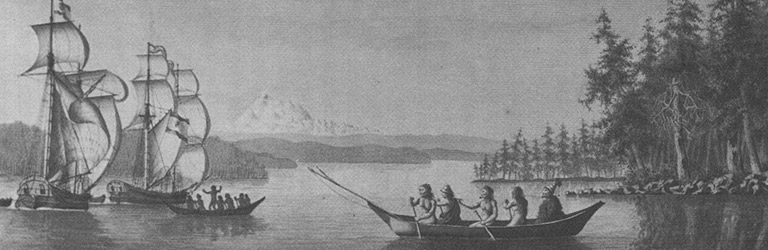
[[219, 94, 501, 164]]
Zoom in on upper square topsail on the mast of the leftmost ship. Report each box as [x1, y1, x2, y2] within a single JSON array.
[[23, 22, 90, 74]]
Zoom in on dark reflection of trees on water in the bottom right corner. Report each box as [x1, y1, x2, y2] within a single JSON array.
[[632, 196, 768, 249]]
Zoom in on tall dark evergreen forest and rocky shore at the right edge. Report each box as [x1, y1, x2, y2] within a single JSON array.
[[476, 0, 768, 184]]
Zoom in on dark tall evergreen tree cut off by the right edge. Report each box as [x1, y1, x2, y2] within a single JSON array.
[[709, 0, 768, 173]]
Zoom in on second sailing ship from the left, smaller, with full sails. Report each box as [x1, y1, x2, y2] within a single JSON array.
[[107, 43, 211, 204]]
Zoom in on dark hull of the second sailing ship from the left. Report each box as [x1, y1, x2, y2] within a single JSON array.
[[107, 181, 188, 204]]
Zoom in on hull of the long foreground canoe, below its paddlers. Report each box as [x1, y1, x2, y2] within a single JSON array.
[[368, 201, 605, 239]]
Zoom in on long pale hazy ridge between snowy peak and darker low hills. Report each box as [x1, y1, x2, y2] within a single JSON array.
[[212, 131, 501, 154]]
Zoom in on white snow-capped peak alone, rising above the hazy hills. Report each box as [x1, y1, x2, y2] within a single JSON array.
[[235, 94, 380, 136]]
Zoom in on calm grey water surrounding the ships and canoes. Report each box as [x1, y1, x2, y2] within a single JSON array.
[[0, 161, 768, 249]]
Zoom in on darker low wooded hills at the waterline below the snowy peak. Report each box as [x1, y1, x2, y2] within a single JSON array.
[[235, 138, 431, 164]]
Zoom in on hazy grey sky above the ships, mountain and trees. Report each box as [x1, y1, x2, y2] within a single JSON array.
[[0, 0, 706, 139]]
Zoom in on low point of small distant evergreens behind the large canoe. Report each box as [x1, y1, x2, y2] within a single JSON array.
[[474, 121, 627, 181]]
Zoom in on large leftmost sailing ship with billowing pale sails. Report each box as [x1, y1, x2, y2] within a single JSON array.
[[15, 0, 128, 210]]
